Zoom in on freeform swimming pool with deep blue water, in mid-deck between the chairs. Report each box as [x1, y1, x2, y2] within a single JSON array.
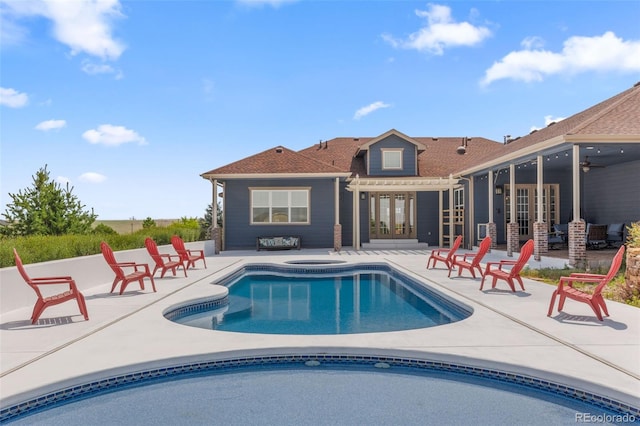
[[165, 264, 472, 335]]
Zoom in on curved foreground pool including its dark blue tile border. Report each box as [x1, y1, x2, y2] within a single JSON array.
[[0, 354, 640, 426]]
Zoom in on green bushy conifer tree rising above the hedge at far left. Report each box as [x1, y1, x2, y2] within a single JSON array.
[[0, 165, 98, 237]]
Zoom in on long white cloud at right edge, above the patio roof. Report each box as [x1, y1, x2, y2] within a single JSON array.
[[481, 31, 640, 86]]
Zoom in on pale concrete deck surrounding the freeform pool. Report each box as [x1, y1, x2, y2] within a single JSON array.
[[0, 249, 640, 407]]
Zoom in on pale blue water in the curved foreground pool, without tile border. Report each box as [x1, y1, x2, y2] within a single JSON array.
[[7, 361, 638, 426]]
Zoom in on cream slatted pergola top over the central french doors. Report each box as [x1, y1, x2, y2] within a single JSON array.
[[346, 177, 461, 192]]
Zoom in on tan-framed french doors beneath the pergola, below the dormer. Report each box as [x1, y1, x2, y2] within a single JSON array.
[[369, 192, 416, 239]]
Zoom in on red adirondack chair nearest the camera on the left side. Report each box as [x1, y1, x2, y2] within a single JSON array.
[[13, 248, 89, 324]]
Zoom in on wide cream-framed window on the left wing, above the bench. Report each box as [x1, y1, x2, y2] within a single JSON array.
[[250, 189, 309, 223]]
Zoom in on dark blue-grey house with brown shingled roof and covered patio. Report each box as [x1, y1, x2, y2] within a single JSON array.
[[201, 84, 640, 264]]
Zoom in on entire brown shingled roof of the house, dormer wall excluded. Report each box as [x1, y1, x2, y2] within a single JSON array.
[[201, 83, 640, 178]]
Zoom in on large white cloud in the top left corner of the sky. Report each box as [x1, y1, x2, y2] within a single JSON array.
[[3, 0, 125, 60]]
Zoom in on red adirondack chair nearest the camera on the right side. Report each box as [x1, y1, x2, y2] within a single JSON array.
[[547, 246, 624, 321]]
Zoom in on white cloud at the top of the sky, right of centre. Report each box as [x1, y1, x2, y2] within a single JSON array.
[[382, 4, 491, 55]]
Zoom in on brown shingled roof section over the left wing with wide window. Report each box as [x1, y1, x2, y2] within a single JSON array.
[[200, 146, 342, 178]]
